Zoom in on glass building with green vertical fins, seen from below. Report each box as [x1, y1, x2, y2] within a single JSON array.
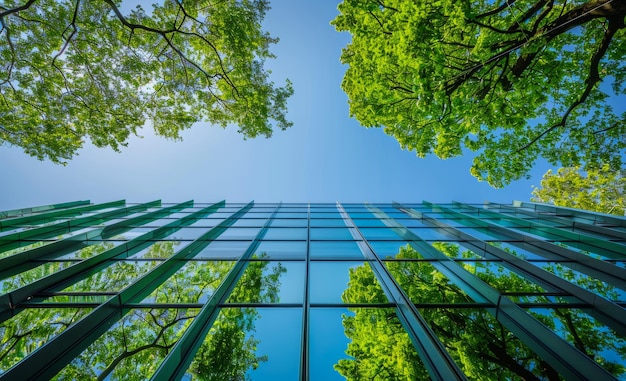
[[0, 200, 626, 381]]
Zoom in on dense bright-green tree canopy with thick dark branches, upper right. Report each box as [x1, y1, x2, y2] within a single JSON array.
[[332, 0, 626, 187]]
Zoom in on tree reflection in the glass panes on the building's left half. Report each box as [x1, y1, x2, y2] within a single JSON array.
[[0, 242, 286, 380]]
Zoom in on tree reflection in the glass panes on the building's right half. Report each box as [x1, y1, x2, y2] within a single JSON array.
[[335, 243, 626, 380]]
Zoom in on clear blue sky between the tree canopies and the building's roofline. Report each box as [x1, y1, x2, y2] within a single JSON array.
[[0, 0, 550, 210]]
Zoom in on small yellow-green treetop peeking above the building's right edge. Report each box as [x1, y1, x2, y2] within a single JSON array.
[[532, 165, 626, 216]]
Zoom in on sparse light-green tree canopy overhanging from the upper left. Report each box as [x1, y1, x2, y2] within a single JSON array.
[[0, 0, 293, 163]]
